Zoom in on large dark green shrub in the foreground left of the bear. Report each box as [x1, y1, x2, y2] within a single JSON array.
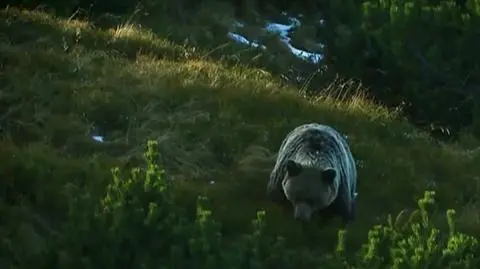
[[46, 142, 318, 268]]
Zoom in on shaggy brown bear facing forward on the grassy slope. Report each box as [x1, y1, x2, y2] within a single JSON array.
[[267, 123, 357, 223]]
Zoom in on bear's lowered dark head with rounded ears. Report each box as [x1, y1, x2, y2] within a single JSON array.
[[282, 160, 338, 221]]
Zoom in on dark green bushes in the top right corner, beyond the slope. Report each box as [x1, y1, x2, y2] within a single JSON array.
[[321, 0, 480, 139]]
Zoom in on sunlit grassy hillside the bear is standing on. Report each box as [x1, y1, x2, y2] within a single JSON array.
[[0, 6, 480, 256]]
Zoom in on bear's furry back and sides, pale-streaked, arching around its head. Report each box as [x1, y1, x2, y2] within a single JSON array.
[[267, 123, 357, 201]]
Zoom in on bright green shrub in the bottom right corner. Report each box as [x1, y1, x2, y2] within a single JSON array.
[[359, 191, 480, 268]]
